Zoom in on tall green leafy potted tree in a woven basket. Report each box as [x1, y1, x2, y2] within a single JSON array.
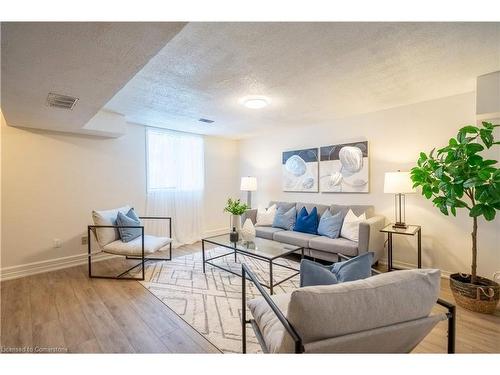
[[411, 122, 500, 313]]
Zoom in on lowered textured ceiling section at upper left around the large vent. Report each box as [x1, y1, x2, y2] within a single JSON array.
[[1, 22, 185, 132]]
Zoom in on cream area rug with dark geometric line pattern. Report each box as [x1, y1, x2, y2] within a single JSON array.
[[141, 247, 299, 353]]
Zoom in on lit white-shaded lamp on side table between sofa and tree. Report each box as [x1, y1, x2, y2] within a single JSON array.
[[384, 171, 415, 229]]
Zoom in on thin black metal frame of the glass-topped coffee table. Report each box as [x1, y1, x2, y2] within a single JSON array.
[[201, 236, 304, 294]]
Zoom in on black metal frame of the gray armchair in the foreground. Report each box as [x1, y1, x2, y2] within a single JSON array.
[[241, 254, 456, 354]]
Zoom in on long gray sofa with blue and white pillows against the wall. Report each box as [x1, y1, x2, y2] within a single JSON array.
[[243, 201, 385, 263]]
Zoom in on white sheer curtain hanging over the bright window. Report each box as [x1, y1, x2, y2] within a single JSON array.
[[146, 128, 205, 246]]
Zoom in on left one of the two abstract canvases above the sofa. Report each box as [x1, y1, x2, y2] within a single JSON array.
[[282, 148, 319, 193]]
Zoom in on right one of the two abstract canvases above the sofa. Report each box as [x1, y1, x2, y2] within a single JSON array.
[[320, 141, 369, 193]]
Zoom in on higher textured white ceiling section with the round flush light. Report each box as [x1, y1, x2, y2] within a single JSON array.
[[106, 23, 500, 138]]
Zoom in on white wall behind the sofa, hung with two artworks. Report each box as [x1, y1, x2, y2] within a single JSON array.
[[240, 93, 500, 277]]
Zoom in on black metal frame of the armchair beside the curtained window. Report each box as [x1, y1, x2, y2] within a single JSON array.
[[87, 216, 172, 281]]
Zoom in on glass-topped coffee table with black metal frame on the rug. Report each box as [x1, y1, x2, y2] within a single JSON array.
[[201, 234, 304, 294]]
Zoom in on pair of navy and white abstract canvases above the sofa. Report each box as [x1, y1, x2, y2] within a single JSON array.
[[282, 141, 369, 193]]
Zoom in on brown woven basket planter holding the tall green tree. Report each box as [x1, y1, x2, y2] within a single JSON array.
[[450, 273, 500, 314]]
